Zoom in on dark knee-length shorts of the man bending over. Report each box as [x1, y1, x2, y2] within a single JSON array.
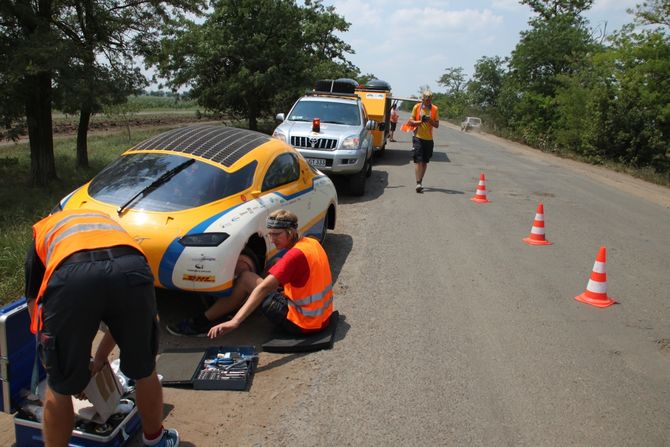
[[40, 253, 158, 395]]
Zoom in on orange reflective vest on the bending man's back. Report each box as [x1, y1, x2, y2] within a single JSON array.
[[30, 209, 142, 333]]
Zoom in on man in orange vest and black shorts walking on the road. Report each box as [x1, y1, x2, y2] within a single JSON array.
[[403, 90, 440, 193]]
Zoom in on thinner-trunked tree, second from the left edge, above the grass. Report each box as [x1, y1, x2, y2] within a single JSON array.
[[55, 0, 206, 167]]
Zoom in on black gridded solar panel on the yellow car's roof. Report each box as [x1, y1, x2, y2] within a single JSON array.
[[131, 126, 270, 166]]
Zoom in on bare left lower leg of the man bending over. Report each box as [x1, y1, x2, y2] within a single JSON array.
[[42, 386, 74, 447]]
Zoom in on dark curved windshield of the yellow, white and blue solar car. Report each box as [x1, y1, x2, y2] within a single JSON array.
[[88, 153, 257, 211]]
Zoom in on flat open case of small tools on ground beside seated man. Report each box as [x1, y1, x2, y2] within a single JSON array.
[[156, 346, 258, 390]]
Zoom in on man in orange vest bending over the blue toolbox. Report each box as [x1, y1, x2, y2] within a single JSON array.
[[26, 210, 179, 447]]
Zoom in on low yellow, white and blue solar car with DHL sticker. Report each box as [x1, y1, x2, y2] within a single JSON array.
[[53, 125, 337, 295]]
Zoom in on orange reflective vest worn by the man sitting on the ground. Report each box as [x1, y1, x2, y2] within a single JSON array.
[[284, 237, 333, 329]]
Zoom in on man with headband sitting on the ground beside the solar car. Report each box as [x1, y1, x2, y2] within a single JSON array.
[[171, 210, 333, 338]]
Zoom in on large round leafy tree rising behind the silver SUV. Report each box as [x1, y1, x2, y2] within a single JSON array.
[[151, 0, 359, 129]]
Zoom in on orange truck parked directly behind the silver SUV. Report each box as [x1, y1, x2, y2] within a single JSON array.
[[355, 79, 393, 153]]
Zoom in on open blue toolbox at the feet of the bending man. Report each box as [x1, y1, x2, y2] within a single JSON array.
[[0, 298, 140, 447]]
